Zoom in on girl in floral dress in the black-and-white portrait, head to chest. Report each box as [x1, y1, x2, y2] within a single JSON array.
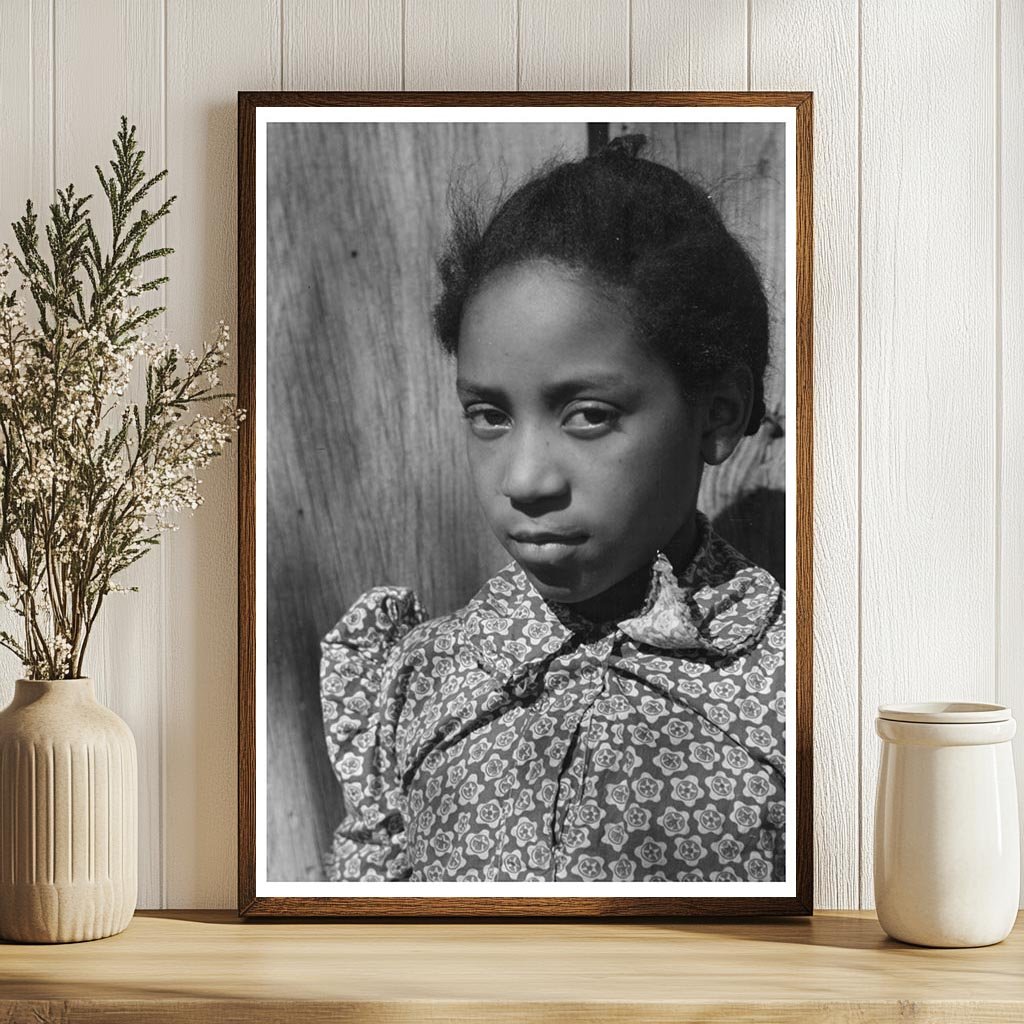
[[321, 136, 785, 882]]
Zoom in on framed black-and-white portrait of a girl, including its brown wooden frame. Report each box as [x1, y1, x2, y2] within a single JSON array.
[[238, 92, 813, 918]]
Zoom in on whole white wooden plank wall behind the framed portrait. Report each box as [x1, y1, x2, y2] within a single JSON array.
[[0, 0, 1024, 907]]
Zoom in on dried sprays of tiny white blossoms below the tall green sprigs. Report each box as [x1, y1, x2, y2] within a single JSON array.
[[0, 253, 245, 674]]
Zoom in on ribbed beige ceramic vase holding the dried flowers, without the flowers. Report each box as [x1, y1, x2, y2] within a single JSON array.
[[0, 679, 138, 942]]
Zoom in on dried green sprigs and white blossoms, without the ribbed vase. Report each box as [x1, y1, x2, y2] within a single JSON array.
[[0, 117, 245, 679]]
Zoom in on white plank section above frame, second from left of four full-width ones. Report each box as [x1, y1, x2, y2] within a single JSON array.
[[402, 0, 516, 90]]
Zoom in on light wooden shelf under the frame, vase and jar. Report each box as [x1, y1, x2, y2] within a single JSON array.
[[0, 910, 1024, 1024]]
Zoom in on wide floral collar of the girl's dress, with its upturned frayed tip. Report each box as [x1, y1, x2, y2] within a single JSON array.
[[466, 512, 782, 670]]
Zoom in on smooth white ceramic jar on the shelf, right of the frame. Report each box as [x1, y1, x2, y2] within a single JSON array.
[[874, 703, 1020, 947]]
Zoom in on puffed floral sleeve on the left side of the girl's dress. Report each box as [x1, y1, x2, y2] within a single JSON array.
[[321, 587, 427, 882]]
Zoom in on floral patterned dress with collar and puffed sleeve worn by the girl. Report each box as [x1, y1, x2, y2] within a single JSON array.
[[321, 513, 785, 882]]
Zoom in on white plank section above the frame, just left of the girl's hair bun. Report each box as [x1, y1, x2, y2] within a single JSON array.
[[519, 0, 630, 89]]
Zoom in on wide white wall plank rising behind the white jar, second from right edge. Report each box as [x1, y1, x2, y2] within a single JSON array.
[[860, 0, 996, 906]]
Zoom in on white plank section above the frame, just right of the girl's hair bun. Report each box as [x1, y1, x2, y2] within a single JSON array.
[[631, 0, 748, 90]]
